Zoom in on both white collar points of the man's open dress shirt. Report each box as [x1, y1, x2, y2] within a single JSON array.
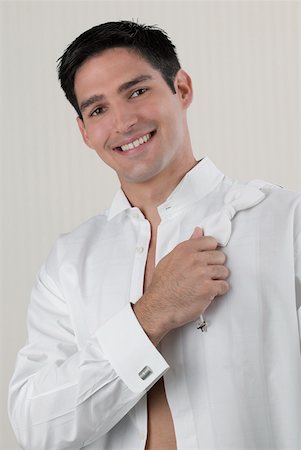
[[107, 157, 224, 220]]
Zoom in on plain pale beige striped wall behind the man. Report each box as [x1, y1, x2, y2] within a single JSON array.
[[0, 1, 301, 450]]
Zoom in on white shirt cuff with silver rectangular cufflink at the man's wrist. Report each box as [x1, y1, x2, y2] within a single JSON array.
[[95, 304, 169, 393]]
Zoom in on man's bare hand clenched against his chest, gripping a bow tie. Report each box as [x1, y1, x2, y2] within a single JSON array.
[[134, 228, 229, 345]]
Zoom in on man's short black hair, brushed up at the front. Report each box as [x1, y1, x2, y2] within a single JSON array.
[[58, 20, 181, 117]]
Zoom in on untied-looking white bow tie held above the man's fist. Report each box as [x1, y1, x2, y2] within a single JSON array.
[[200, 182, 265, 247]]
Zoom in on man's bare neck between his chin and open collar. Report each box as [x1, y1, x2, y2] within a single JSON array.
[[121, 156, 197, 223]]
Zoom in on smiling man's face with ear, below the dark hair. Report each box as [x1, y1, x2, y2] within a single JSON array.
[[74, 48, 192, 186]]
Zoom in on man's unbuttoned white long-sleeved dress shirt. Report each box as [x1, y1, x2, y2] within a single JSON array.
[[9, 158, 301, 450]]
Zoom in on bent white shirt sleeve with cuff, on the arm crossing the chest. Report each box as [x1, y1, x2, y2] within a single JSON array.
[[9, 267, 168, 450]]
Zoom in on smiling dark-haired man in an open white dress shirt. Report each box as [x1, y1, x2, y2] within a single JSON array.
[[10, 22, 301, 450]]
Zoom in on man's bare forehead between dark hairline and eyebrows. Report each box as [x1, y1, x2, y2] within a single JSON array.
[[74, 47, 163, 99]]
